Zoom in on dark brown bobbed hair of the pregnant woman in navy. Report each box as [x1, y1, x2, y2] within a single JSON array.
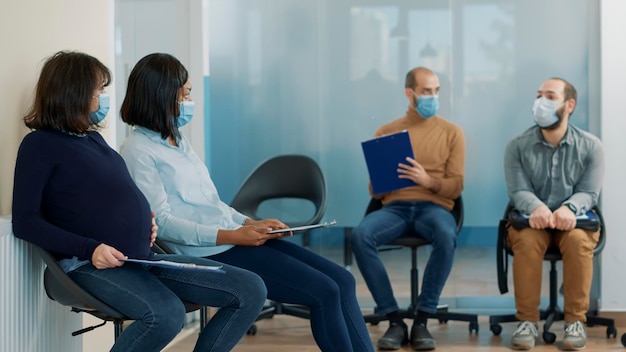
[[24, 51, 111, 134]]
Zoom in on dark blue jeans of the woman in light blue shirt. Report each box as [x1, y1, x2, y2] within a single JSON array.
[[210, 240, 374, 352]]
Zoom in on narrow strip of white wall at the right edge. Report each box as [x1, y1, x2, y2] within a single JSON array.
[[600, 0, 626, 311]]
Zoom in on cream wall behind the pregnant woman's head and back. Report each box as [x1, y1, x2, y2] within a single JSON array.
[[0, 0, 115, 214]]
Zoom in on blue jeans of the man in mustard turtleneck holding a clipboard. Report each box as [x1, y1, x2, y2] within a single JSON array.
[[351, 201, 456, 314]]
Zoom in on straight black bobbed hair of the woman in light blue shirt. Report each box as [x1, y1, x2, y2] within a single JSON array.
[[120, 53, 189, 139]]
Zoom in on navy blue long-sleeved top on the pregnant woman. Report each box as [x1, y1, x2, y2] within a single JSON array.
[[13, 130, 152, 260]]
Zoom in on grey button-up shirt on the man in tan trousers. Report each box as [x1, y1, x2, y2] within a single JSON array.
[[504, 125, 604, 215]]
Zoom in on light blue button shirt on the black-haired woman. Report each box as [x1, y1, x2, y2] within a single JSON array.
[[120, 127, 247, 257]]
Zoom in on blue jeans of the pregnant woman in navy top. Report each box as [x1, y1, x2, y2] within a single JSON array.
[[68, 254, 267, 352]]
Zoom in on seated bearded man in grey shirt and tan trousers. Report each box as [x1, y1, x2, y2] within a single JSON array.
[[504, 78, 604, 350]]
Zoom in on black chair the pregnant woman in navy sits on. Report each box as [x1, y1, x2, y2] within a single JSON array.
[[33, 246, 202, 340]]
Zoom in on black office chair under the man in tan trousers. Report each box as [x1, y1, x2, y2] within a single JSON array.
[[489, 204, 617, 344]]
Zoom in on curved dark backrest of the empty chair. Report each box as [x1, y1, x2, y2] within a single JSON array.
[[231, 155, 326, 227]]
